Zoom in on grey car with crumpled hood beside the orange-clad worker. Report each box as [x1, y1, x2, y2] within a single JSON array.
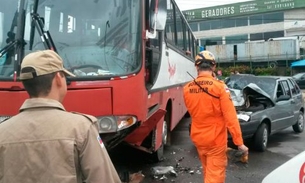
[[226, 75, 304, 151]]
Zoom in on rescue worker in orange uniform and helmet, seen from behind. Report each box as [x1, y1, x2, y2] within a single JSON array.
[[184, 51, 248, 183]]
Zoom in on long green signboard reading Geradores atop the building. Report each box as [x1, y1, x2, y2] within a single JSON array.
[[183, 0, 305, 20]]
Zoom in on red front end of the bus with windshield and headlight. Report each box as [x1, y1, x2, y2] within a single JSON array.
[[0, 0, 147, 149]]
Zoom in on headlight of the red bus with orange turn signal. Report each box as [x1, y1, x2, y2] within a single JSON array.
[[98, 116, 137, 133]]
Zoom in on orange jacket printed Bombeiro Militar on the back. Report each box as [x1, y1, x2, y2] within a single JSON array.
[[184, 74, 243, 147]]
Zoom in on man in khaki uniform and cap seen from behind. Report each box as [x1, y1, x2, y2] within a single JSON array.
[[0, 50, 121, 183]]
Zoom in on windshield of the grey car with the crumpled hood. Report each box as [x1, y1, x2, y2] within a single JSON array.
[[226, 75, 276, 97]]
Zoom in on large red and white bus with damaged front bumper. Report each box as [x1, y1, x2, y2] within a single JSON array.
[[0, 0, 197, 160]]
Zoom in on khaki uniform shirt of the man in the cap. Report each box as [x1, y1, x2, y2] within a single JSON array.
[[0, 98, 121, 183]]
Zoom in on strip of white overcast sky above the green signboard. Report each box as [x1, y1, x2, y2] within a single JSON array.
[[176, 0, 249, 11]]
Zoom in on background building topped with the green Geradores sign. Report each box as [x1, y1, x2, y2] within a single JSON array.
[[183, 0, 305, 65]]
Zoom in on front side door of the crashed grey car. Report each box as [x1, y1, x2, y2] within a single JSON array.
[[272, 80, 294, 131]]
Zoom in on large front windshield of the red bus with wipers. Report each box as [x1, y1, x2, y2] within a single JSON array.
[[0, 0, 141, 79]]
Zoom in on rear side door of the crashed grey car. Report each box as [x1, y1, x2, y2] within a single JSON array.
[[288, 79, 303, 122]]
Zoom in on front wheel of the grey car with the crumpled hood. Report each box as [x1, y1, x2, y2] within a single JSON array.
[[253, 123, 269, 152]]
